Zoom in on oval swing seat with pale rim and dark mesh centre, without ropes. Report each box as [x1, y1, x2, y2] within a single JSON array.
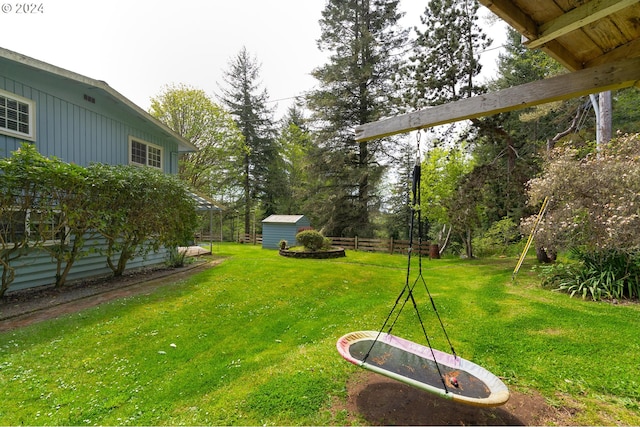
[[337, 331, 509, 406]]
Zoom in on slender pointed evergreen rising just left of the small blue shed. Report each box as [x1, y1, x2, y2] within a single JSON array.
[[221, 47, 281, 233]]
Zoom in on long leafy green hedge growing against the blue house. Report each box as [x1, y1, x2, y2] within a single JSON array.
[[0, 144, 197, 296]]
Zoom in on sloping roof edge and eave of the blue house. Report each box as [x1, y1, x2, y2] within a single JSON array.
[[0, 47, 197, 152]]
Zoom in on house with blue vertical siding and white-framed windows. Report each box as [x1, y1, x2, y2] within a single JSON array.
[[0, 48, 196, 291]]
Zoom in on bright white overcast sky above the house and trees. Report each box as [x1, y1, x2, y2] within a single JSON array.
[[0, 0, 504, 118]]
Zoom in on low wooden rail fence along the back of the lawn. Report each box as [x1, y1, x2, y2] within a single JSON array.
[[238, 234, 440, 258]]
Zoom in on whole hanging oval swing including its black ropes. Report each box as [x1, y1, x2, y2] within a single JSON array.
[[336, 143, 509, 406]]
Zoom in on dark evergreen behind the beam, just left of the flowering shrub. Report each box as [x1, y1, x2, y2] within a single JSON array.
[[469, 29, 564, 230]]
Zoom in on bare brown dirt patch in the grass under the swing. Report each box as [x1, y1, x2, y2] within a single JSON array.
[[332, 371, 575, 426]]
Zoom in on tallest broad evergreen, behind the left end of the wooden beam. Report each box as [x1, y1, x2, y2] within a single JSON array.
[[308, 0, 407, 236]]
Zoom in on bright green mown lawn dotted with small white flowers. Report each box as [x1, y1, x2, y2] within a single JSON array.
[[0, 244, 640, 425]]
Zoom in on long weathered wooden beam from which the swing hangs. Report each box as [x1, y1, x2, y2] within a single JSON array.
[[355, 57, 640, 142]]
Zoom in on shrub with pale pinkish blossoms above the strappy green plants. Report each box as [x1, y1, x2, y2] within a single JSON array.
[[522, 134, 640, 250]]
